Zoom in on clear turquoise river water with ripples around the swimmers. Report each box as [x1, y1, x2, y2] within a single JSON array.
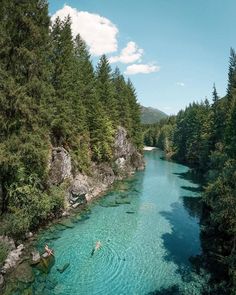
[[33, 151, 205, 295]]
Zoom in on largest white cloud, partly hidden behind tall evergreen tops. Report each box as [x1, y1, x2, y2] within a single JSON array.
[[51, 5, 118, 56]]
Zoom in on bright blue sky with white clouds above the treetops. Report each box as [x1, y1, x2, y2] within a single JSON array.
[[49, 0, 236, 114]]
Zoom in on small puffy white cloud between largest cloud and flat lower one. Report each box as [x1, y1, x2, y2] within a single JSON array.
[[109, 41, 143, 64]]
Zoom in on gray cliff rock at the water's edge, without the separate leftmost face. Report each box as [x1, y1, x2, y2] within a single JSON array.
[[68, 127, 144, 208]]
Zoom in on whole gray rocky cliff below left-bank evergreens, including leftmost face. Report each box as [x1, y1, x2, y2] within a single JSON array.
[[49, 127, 144, 208]]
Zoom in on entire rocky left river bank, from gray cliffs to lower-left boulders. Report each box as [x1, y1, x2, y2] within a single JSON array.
[[0, 127, 144, 289]]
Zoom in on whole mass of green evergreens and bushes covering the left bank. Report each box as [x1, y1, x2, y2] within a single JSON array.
[[0, 0, 142, 236]]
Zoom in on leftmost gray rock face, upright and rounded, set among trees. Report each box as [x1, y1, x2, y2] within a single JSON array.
[[49, 147, 72, 185]]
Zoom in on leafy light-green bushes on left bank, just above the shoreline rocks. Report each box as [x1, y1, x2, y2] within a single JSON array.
[[0, 168, 64, 236]]
